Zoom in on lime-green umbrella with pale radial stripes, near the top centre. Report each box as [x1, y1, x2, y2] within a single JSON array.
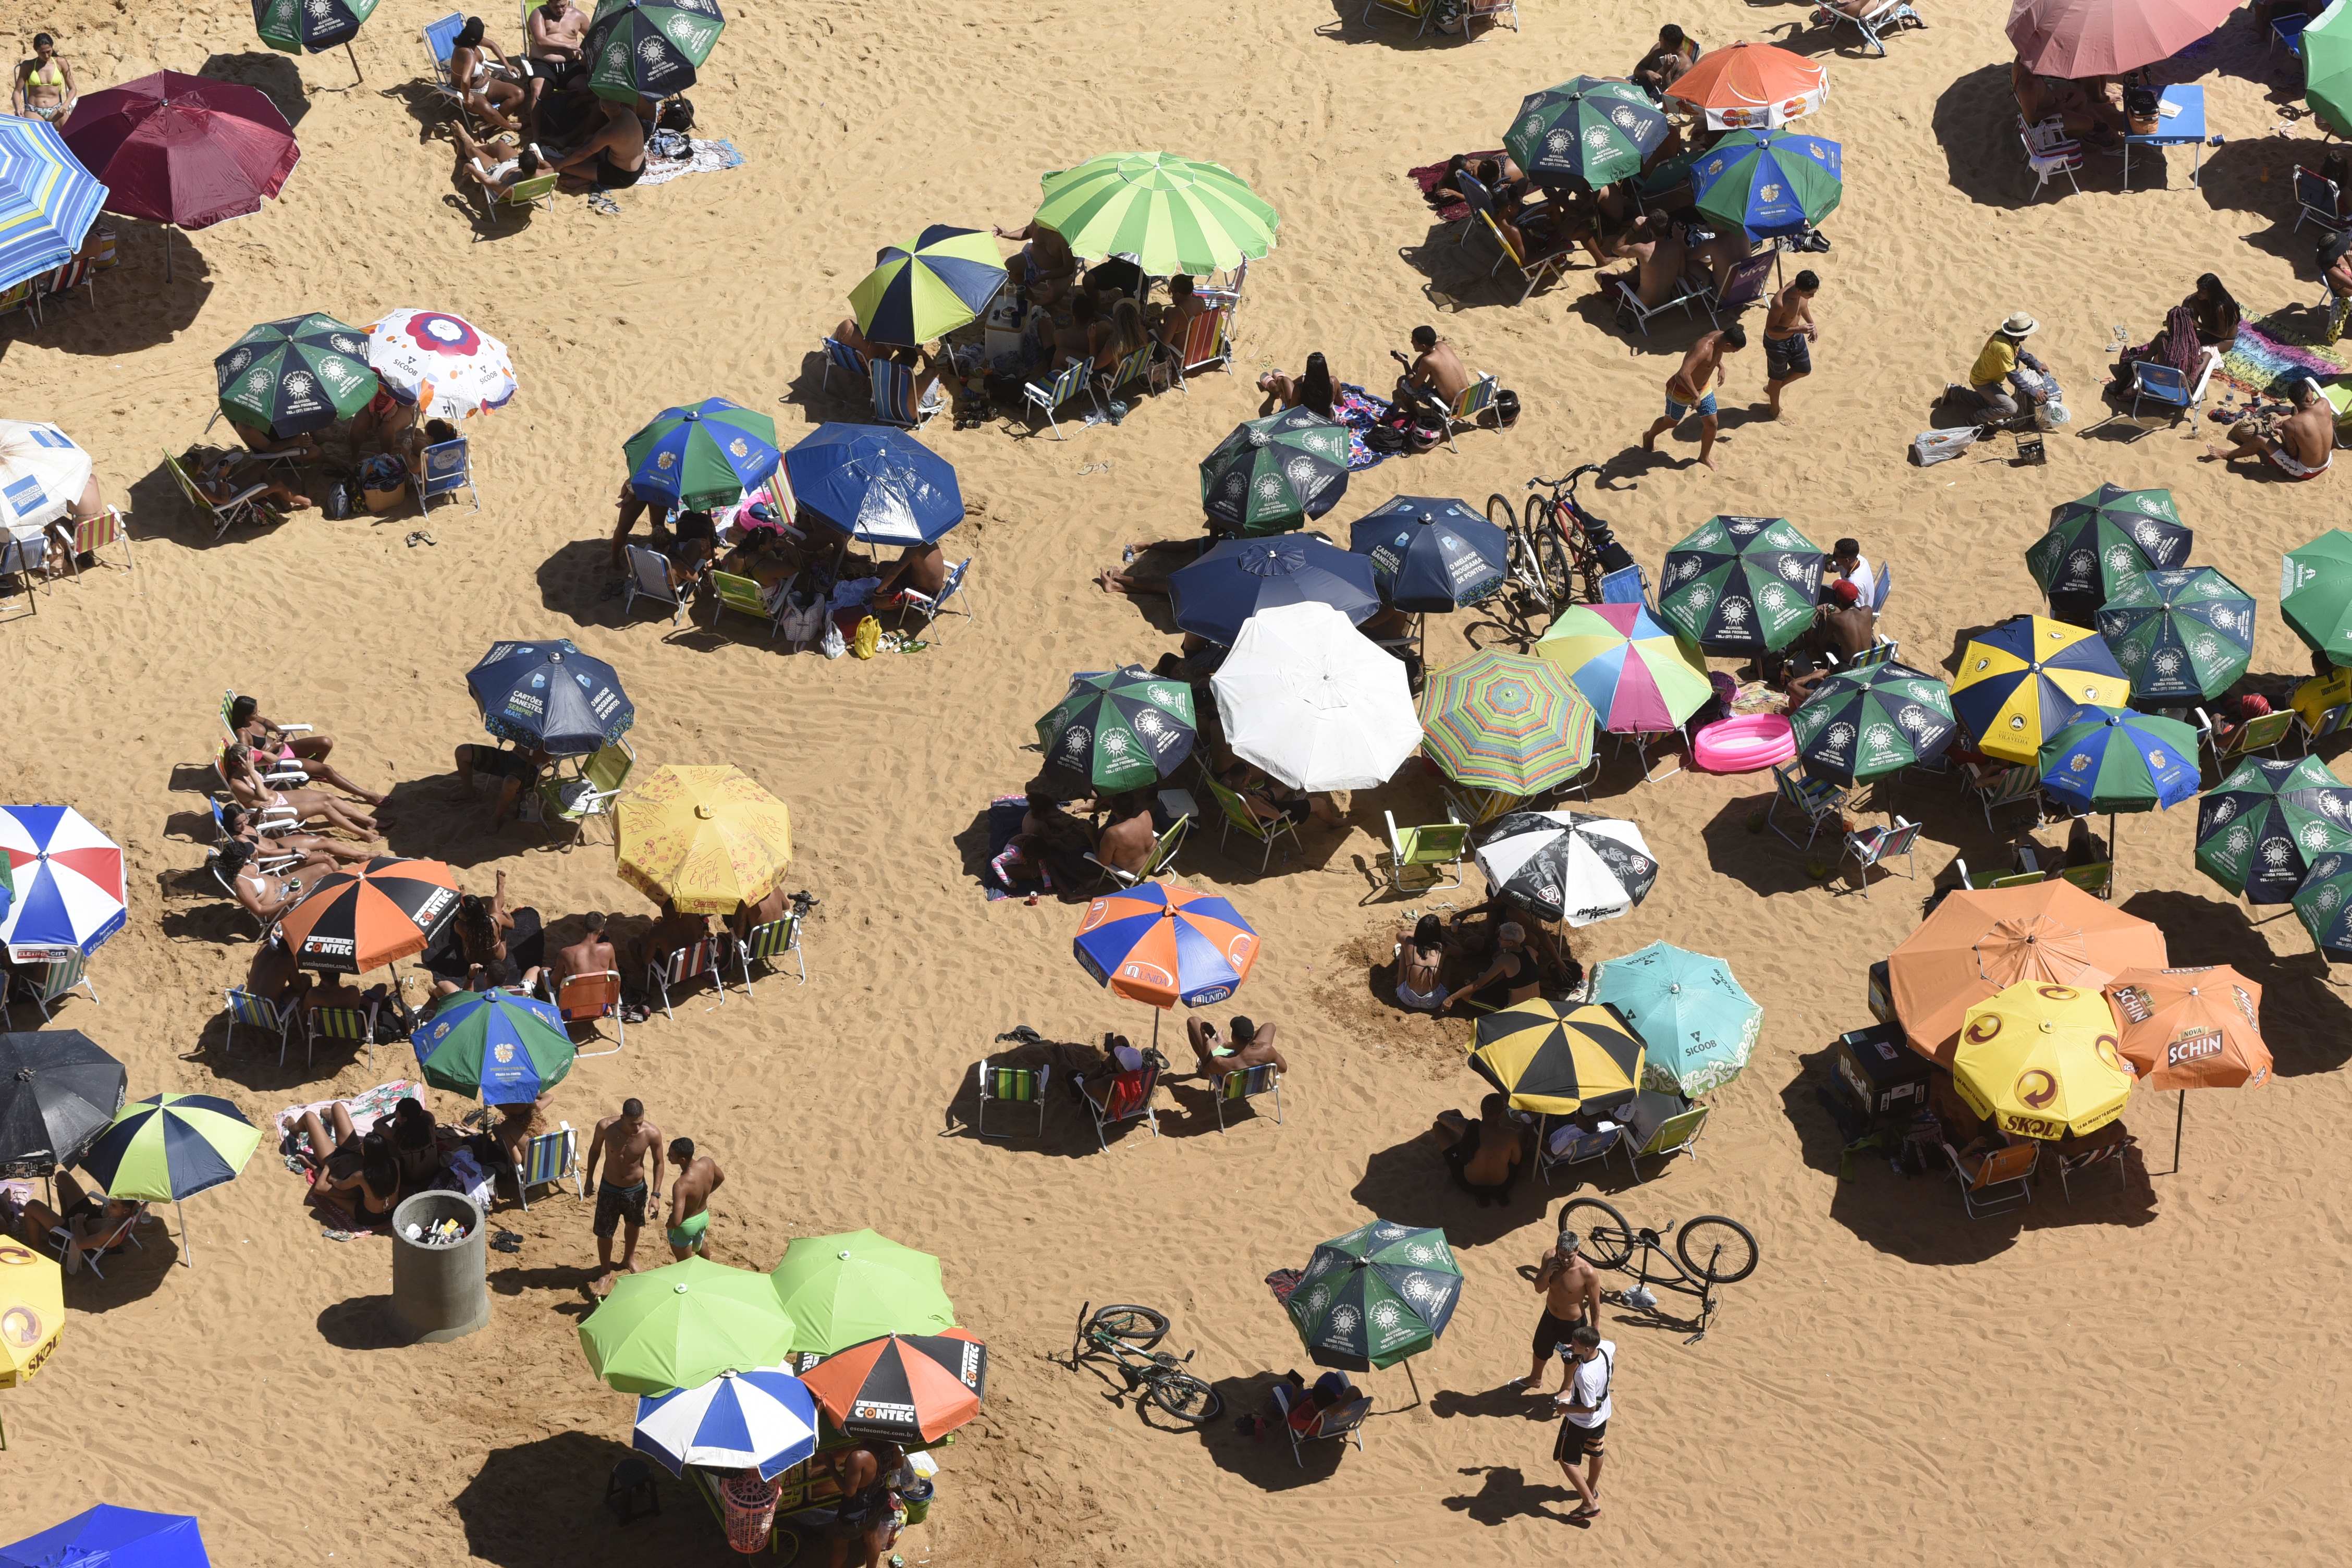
[[1037, 153, 1282, 277]]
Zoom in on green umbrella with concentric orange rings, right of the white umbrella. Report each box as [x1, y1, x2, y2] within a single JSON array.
[[1420, 649, 1592, 794]]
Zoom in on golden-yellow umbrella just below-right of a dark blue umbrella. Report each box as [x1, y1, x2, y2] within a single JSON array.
[[616, 766, 793, 914]]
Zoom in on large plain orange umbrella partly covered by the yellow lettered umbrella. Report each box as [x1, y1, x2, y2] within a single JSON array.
[[1886, 881, 2166, 1067]]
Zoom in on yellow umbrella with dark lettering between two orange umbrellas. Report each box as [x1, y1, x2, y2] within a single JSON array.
[[1952, 981, 2131, 1140]]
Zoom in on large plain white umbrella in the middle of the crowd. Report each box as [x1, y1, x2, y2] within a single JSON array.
[[1211, 602, 1420, 792]]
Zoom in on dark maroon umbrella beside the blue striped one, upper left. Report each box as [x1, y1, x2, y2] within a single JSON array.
[[64, 70, 301, 228]]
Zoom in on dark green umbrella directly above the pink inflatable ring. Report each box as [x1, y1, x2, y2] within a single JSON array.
[[1658, 517, 1825, 654]]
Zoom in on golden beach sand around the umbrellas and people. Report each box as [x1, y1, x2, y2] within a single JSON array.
[[0, 0, 2352, 1568]]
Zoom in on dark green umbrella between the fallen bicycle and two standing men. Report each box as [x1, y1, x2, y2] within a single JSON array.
[[1282, 1220, 1463, 1373]]
